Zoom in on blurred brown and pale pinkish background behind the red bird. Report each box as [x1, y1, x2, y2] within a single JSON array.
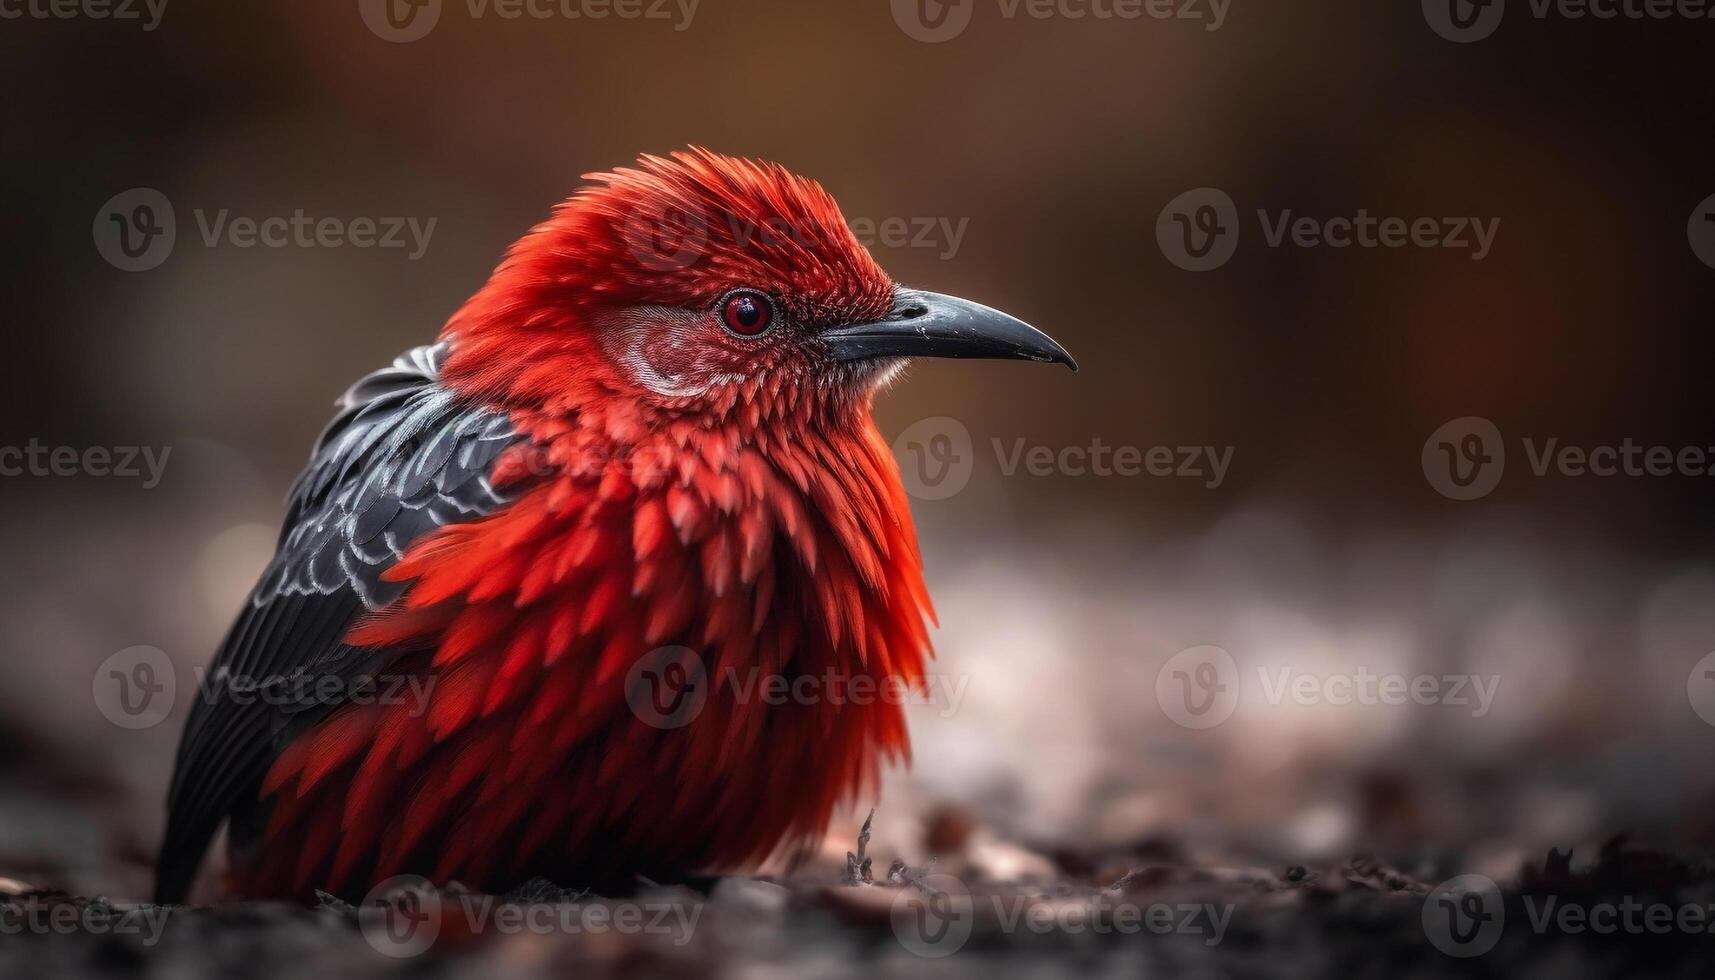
[[0, 0, 1715, 896]]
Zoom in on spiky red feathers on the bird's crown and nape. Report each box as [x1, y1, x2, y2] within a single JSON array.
[[444, 149, 894, 407]]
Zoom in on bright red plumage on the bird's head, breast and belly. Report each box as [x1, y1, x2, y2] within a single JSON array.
[[235, 154, 930, 896]]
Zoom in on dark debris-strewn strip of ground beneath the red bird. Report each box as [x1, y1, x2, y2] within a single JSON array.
[[0, 841, 1715, 980]]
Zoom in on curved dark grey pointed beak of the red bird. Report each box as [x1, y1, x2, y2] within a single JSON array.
[[821, 288, 1077, 371]]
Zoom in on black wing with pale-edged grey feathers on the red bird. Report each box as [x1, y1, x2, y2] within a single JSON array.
[[156, 345, 520, 903]]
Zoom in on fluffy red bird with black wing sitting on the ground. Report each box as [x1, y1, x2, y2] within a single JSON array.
[[156, 149, 1072, 903]]
